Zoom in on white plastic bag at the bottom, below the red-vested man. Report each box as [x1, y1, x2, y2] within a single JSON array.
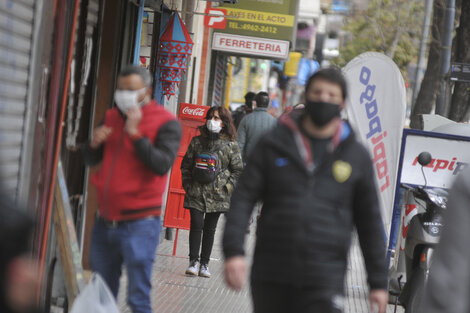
[[70, 273, 119, 313]]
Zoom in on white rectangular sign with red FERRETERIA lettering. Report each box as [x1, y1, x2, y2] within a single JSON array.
[[212, 33, 289, 59]]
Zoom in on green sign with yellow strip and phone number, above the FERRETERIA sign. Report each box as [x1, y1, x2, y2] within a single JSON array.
[[217, 0, 298, 41]]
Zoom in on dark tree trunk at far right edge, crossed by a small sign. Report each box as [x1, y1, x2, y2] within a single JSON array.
[[449, 1, 470, 122]]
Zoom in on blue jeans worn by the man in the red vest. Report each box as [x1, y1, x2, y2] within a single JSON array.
[[90, 217, 161, 313]]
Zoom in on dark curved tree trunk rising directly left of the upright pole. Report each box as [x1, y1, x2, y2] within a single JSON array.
[[410, 0, 445, 129]]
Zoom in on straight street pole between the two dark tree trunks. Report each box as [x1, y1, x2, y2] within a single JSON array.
[[436, 0, 455, 116]]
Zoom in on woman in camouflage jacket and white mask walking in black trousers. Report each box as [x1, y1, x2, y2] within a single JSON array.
[[181, 107, 243, 278]]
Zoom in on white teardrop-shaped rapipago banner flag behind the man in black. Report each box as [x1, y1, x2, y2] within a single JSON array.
[[343, 52, 406, 231]]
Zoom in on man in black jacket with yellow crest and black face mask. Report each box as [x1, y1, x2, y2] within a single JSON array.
[[223, 68, 388, 313]]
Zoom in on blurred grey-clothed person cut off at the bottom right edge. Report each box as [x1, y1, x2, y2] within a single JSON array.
[[419, 170, 470, 313]]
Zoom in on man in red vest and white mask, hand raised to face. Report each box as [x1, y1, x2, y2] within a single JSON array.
[[84, 66, 181, 313]]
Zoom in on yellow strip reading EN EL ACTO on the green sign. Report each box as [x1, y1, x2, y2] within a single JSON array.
[[224, 7, 295, 27]]
